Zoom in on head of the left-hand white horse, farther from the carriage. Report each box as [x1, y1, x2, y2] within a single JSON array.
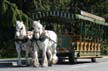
[[15, 21, 26, 39]]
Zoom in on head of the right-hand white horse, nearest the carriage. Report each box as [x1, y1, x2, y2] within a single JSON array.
[[33, 20, 45, 39]]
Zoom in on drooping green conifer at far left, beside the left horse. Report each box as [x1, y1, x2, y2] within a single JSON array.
[[0, 0, 32, 57]]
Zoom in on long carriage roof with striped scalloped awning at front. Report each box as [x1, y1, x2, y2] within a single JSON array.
[[32, 10, 108, 26]]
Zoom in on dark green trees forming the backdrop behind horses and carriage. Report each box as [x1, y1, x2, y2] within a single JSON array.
[[0, 0, 108, 57]]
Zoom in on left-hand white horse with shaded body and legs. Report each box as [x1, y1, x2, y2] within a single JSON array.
[[15, 21, 33, 66]]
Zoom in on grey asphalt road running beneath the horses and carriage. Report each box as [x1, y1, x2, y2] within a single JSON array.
[[0, 58, 108, 71]]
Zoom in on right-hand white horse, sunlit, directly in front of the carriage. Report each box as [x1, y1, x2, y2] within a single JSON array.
[[33, 21, 58, 67]]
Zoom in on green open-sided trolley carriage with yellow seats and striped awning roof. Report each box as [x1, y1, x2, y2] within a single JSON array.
[[32, 11, 107, 63]]
